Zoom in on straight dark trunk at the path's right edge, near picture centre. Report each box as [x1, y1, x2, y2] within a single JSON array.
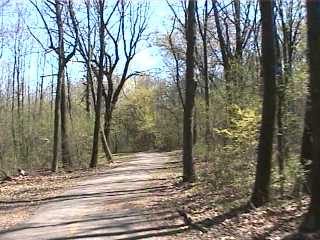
[[183, 0, 196, 182]]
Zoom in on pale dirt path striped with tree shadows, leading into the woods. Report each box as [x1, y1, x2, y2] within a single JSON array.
[[0, 153, 186, 240]]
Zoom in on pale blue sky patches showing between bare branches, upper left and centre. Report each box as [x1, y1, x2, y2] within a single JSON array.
[[0, 0, 175, 93]]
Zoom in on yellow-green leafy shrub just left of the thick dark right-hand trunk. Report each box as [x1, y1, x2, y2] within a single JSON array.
[[209, 105, 260, 190]]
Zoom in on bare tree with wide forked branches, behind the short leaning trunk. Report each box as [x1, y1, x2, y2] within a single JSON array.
[[103, 1, 149, 161]]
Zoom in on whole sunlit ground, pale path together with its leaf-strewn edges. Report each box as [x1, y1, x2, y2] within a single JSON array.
[[0, 152, 320, 240]]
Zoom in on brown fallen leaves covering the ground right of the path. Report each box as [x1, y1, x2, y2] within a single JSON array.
[[146, 153, 314, 240]]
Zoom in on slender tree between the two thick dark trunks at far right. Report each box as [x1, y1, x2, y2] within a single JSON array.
[[276, 0, 305, 193]]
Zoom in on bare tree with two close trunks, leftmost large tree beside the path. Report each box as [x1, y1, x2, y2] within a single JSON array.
[[30, 0, 78, 171]]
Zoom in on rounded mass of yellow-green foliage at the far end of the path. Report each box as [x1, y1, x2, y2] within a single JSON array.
[[111, 79, 182, 151]]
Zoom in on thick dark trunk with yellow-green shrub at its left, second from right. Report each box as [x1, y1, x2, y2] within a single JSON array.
[[251, 0, 276, 207]]
